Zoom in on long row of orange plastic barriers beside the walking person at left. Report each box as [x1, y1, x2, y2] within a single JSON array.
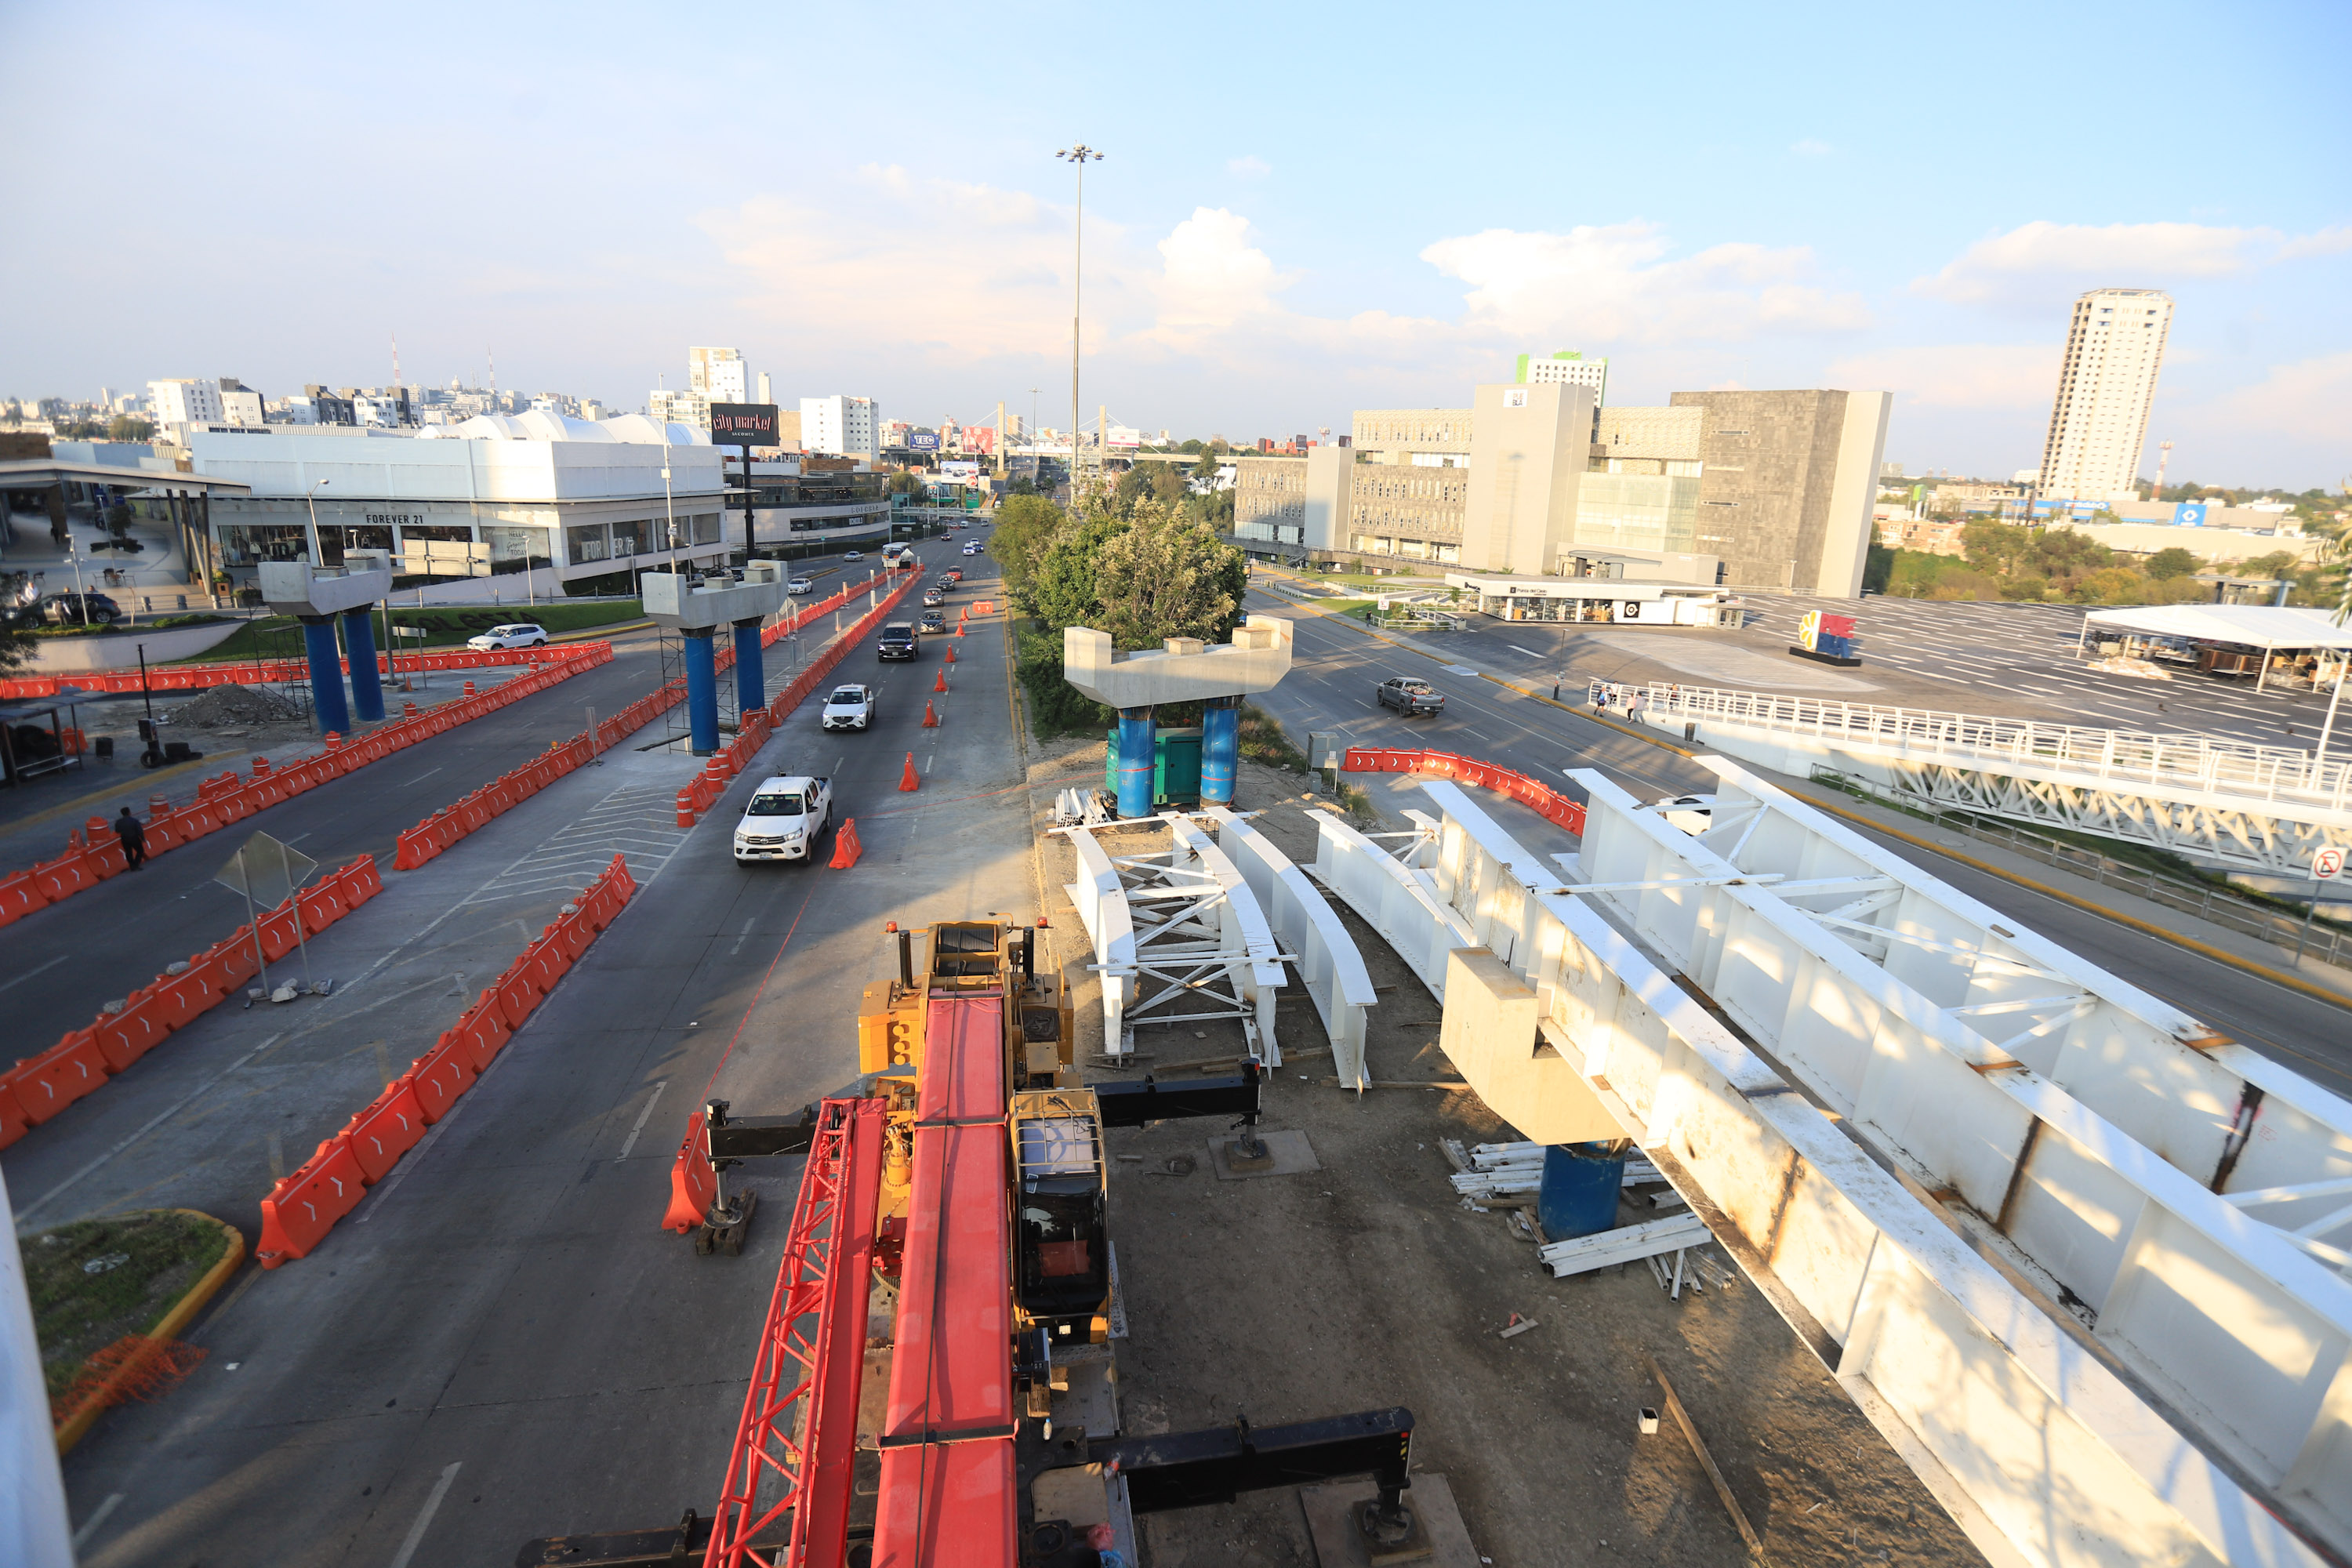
[[0, 642, 612, 926]]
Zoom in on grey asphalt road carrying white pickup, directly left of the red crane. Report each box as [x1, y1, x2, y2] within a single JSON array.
[[53, 546, 1035, 1568]]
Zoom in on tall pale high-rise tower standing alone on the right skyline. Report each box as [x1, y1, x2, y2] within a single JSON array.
[[2039, 289, 2173, 501]]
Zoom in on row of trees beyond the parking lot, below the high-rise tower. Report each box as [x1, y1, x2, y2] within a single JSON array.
[[1863, 520, 2343, 607]]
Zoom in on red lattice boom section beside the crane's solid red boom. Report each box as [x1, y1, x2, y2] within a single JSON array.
[[703, 1100, 884, 1568]]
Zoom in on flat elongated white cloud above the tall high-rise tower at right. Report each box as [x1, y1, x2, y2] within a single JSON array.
[[1910, 221, 2352, 303]]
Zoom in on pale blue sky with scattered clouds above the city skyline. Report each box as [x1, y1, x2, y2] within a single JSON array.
[[0, 0, 2352, 489]]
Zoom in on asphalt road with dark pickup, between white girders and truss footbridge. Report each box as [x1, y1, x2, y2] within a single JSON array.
[[1249, 593, 2352, 1093]]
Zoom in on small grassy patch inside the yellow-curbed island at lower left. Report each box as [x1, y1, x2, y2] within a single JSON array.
[[19, 1208, 228, 1399]]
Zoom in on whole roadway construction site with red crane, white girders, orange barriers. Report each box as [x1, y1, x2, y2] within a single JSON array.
[[0, 540, 2352, 1568]]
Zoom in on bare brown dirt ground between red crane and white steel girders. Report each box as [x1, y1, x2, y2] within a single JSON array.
[[1030, 741, 1983, 1568]]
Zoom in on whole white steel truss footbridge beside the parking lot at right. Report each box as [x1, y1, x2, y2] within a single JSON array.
[[1590, 682, 2352, 877]]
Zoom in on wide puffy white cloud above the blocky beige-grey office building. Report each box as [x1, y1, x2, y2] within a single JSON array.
[[1421, 221, 1870, 343]]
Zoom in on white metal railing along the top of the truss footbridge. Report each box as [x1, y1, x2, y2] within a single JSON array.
[[1588, 682, 2352, 811]]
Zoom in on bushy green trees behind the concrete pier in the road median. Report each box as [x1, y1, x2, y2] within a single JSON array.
[[988, 479, 1249, 736]]
